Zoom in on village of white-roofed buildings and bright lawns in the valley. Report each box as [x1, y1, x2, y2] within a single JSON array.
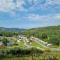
[[0, 35, 52, 49]]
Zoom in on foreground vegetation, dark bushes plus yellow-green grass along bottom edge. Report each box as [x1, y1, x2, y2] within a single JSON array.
[[0, 48, 60, 60]]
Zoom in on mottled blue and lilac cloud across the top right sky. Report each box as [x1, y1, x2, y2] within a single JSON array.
[[28, 0, 60, 9]]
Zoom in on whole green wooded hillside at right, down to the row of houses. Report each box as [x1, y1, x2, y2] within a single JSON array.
[[24, 26, 60, 45]]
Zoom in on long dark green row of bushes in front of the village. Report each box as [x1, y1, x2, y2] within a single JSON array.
[[0, 47, 43, 56]]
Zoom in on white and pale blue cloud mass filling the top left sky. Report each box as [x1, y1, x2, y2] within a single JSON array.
[[0, 0, 24, 12]]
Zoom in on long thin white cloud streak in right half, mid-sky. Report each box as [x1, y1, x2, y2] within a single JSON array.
[[24, 14, 60, 21]]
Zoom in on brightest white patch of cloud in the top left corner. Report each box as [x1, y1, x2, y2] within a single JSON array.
[[0, 0, 15, 11]]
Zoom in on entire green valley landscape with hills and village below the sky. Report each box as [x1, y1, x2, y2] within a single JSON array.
[[0, 26, 60, 60]]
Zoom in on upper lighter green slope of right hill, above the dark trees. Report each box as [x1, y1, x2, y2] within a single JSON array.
[[24, 26, 60, 38]]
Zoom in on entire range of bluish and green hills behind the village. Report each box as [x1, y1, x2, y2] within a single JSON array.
[[0, 26, 60, 45]]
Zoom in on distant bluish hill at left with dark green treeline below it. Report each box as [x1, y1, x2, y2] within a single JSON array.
[[0, 27, 25, 37]]
